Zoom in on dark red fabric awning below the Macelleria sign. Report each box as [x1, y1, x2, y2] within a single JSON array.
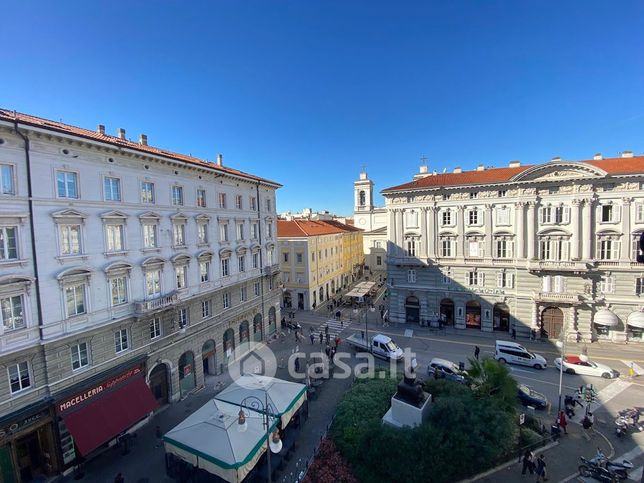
[[63, 377, 158, 455]]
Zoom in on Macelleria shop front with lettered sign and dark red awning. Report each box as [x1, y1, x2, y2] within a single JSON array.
[[55, 362, 159, 463]]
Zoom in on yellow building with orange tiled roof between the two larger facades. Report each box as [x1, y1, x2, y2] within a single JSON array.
[[277, 219, 364, 310]]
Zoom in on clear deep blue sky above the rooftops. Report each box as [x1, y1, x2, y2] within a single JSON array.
[[0, 0, 644, 214]]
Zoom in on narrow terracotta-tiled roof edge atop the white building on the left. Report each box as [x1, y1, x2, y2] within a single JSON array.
[[0, 109, 282, 187]]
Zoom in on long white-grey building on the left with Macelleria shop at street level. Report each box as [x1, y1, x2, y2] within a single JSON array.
[[0, 110, 280, 481]]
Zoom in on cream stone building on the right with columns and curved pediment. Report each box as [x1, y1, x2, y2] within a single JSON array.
[[382, 152, 644, 342]]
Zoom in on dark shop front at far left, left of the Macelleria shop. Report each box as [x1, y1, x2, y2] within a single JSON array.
[[0, 401, 59, 483]]
